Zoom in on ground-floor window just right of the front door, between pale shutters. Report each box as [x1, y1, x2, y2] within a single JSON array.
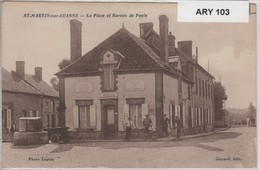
[[129, 104, 142, 128]]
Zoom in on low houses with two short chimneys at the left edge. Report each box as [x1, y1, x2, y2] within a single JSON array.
[[2, 61, 59, 140]]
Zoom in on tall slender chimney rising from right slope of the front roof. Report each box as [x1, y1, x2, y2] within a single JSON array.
[[159, 15, 169, 64]]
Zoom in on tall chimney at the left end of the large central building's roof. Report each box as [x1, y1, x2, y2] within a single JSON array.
[[70, 19, 82, 62]]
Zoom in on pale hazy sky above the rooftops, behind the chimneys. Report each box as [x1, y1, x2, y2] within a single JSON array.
[[2, 2, 256, 108]]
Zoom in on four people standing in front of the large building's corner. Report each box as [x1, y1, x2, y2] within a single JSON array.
[[125, 114, 183, 141]]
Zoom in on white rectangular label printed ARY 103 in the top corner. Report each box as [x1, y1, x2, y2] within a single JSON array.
[[178, 0, 249, 22]]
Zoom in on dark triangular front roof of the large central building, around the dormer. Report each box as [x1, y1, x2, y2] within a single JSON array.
[[57, 28, 171, 75]]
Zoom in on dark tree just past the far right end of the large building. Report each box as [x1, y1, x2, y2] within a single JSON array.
[[213, 82, 227, 121]]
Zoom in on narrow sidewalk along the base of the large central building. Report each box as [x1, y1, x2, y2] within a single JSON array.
[[70, 128, 225, 143]]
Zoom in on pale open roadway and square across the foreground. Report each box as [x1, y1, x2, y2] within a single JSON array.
[[2, 127, 256, 168]]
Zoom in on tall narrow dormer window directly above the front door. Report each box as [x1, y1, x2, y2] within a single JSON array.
[[103, 64, 115, 91]]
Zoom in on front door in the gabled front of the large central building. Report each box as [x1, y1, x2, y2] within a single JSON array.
[[105, 106, 116, 139]]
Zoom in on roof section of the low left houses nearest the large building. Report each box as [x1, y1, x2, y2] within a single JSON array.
[[24, 75, 59, 97]]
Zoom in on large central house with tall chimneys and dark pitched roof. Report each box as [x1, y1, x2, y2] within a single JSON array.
[[57, 15, 214, 138]]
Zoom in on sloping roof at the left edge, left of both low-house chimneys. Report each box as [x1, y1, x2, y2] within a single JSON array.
[[2, 68, 41, 95]]
